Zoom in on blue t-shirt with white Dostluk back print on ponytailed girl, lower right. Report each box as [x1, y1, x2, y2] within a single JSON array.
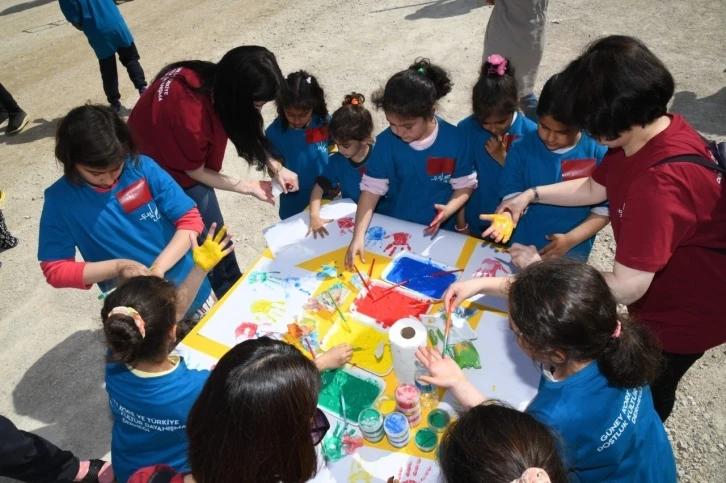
[[527, 362, 677, 483]]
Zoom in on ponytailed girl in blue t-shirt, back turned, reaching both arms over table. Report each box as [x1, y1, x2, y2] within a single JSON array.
[[417, 258, 677, 483]]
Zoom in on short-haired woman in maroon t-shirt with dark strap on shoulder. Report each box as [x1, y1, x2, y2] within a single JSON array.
[[493, 35, 726, 421]]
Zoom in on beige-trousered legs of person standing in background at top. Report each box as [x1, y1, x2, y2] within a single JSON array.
[[482, 0, 549, 121]]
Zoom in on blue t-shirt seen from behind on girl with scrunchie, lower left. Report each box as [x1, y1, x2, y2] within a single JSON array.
[[106, 358, 209, 481]]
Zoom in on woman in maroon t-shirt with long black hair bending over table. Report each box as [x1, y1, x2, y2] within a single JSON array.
[[128, 46, 298, 297]]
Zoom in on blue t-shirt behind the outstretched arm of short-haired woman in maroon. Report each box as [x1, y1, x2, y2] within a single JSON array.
[[499, 131, 607, 261]]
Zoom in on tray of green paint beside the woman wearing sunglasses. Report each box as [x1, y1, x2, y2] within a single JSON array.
[[318, 370, 381, 422]]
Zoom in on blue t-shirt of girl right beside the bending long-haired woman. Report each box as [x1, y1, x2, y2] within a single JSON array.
[[265, 115, 330, 220]]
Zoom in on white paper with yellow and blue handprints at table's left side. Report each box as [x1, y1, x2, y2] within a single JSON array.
[[199, 257, 323, 347]]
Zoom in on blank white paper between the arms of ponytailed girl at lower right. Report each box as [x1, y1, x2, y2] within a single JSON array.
[[443, 311, 541, 411]]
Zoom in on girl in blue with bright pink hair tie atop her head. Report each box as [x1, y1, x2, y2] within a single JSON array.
[[456, 55, 537, 237]]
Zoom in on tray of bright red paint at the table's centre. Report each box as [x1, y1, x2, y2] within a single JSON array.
[[355, 285, 429, 329]]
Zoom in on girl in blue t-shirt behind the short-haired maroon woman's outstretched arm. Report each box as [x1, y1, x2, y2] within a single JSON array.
[[486, 75, 610, 261]]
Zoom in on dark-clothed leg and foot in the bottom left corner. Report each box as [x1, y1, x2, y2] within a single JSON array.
[[0, 416, 114, 483]]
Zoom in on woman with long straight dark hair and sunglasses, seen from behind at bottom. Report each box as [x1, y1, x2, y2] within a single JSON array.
[[129, 337, 329, 483]]
